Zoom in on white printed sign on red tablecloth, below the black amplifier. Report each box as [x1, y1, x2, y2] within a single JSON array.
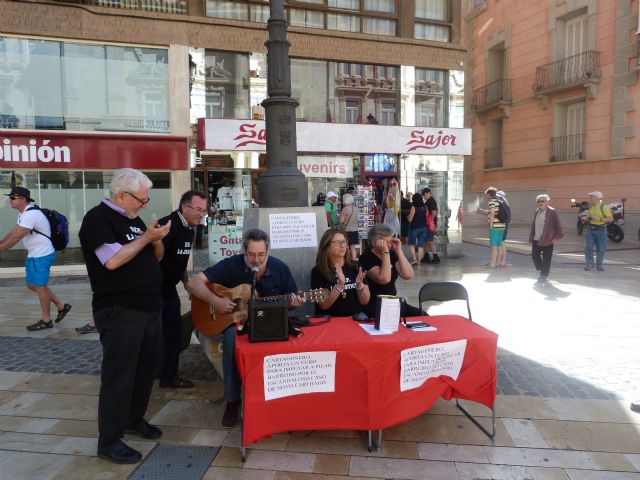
[[263, 352, 336, 401]]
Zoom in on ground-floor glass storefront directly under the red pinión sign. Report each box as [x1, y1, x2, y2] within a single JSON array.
[[0, 170, 172, 267]]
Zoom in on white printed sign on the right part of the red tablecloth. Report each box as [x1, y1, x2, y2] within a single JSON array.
[[400, 339, 467, 392]]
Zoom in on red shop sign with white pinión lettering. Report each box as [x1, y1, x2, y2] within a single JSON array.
[[0, 130, 189, 170]]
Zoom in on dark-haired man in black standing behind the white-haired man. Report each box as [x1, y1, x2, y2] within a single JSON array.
[[158, 190, 207, 388]]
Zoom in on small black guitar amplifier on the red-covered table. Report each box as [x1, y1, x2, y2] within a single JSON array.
[[248, 300, 289, 342]]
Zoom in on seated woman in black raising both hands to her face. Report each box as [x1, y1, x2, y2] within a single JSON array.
[[359, 223, 424, 317]]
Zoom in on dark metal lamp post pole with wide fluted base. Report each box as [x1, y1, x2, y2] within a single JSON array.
[[257, 0, 308, 207]]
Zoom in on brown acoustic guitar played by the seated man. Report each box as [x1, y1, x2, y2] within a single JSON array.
[[191, 282, 329, 336]]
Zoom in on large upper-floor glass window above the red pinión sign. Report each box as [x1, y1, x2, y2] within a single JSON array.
[[0, 37, 170, 133]]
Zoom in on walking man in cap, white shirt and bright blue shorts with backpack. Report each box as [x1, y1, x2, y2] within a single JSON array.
[[0, 187, 71, 332]]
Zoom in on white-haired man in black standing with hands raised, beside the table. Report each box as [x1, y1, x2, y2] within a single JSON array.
[[79, 168, 171, 463]]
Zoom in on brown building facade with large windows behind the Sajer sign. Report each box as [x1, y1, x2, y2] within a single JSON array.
[[0, 0, 465, 262]]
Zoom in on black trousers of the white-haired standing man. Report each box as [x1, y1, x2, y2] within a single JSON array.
[[94, 305, 162, 447]]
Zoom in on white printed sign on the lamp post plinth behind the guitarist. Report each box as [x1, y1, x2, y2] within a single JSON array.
[[269, 213, 318, 248]]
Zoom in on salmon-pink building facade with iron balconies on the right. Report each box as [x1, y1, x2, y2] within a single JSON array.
[[464, 0, 640, 221]]
